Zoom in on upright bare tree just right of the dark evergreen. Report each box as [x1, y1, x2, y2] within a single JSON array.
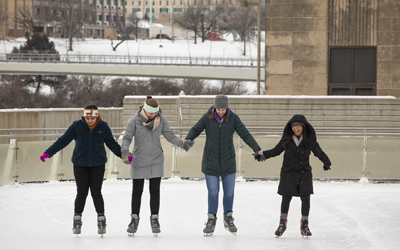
[[48, 0, 96, 51]]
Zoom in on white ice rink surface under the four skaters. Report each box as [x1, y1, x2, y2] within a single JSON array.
[[0, 179, 400, 250]]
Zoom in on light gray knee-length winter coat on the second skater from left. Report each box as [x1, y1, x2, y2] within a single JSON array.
[[121, 112, 183, 179]]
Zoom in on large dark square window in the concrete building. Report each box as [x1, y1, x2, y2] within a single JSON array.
[[328, 47, 376, 95]]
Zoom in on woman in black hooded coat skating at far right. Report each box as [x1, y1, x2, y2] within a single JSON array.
[[256, 115, 331, 237]]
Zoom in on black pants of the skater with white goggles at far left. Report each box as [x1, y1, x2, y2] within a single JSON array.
[[74, 165, 105, 213]]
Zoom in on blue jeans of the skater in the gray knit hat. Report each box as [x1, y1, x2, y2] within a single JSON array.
[[205, 173, 236, 214]]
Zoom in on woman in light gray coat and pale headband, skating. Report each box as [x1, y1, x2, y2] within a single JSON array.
[[121, 96, 189, 235]]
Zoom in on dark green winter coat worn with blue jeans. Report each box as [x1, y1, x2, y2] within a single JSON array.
[[186, 107, 261, 176]]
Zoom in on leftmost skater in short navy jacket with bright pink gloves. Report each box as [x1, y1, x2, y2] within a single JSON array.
[[40, 105, 121, 235]]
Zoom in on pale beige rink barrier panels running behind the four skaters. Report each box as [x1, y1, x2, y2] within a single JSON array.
[[0, 127, 400, 186]]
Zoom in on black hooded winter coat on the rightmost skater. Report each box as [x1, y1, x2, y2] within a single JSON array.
[[264, 115, 331, 196]]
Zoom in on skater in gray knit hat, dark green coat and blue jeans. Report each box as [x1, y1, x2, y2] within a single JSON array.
[[186, 95, 261, 235]]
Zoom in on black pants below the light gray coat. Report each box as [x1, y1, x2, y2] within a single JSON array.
[[131, 177, 161, 215]]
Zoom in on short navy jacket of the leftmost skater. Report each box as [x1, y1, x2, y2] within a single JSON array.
[[45, 117, 121, 167]]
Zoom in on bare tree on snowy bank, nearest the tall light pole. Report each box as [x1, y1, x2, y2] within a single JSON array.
[[222, 0, 257, 55]]
